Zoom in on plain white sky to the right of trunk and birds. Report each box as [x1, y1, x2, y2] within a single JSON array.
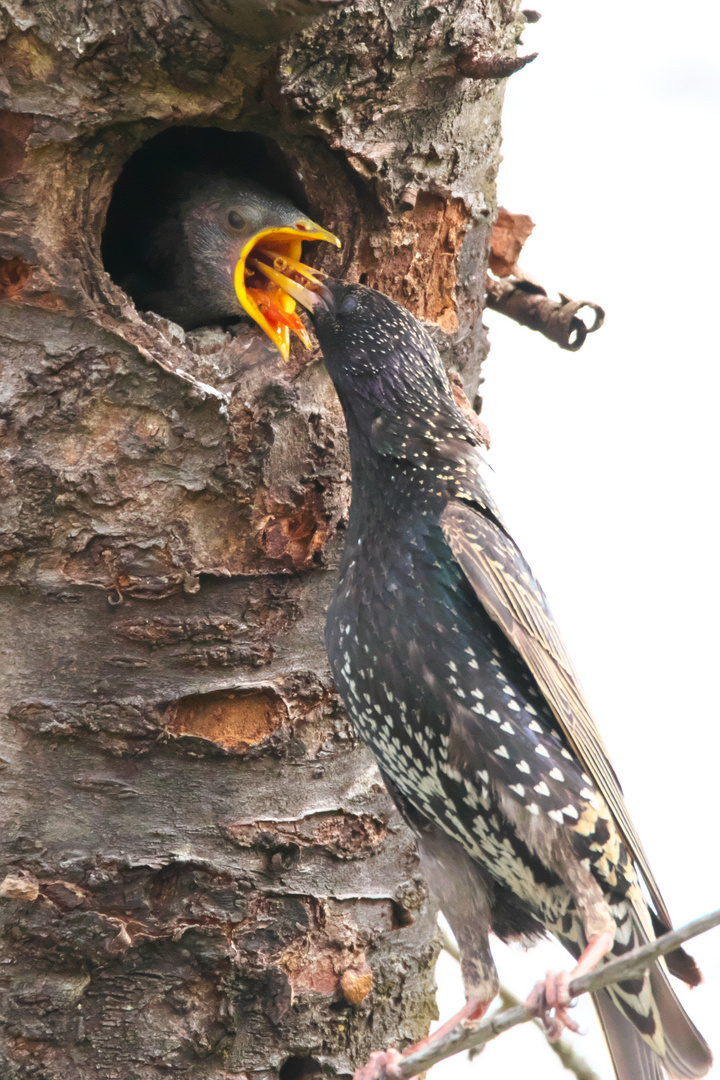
[[432, 0, 720, 1080]]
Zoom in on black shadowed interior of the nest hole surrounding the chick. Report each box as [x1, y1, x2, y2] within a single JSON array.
[[100, 127, 309, 329]]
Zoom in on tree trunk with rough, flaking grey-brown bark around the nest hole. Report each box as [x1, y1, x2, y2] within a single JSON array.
[[0, 0, 522, 1080]]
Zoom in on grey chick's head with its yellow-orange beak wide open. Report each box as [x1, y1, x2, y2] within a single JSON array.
[[179, 177, 340, 360]]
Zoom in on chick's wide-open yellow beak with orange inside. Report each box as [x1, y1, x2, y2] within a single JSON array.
[[235, 218, 342, 360]]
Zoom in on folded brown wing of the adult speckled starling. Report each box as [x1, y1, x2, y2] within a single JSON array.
[[440, 501, 670, 927]]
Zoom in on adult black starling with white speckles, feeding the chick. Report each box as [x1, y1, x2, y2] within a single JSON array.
[[255, 263, 711, 1080]]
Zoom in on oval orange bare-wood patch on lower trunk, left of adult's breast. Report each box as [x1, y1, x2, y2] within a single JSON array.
[[165, 690, 287, 753]]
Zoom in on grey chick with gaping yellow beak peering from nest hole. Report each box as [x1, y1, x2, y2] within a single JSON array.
[[113, 173, 340, 360]]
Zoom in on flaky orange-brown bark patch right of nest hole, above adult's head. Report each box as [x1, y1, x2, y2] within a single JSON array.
[[365, 191, 470, 334]]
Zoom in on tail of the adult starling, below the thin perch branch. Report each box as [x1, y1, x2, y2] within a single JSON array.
[[561, 901, 712, 1080]]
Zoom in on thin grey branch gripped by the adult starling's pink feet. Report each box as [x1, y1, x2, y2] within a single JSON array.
[[393, 910, 720, 1080]]
